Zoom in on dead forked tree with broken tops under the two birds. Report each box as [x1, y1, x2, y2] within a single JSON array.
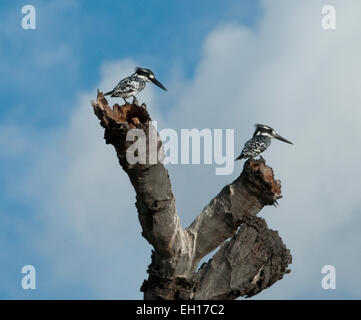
[[92, 92, 292, 300]]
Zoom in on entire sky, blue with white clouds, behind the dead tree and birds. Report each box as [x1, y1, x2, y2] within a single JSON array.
[[0, 0, 361, 299]]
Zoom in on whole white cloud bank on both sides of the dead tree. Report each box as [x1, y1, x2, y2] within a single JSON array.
[[17, 1, 361, 298]]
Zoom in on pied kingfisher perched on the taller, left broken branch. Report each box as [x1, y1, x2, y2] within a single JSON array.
[[104, 67, 167, 103]]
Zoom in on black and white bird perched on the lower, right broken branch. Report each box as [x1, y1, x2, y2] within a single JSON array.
[[236, 124, 293, 160]]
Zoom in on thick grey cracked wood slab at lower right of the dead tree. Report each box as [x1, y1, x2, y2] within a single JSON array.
[[195, 216, 292, 300]]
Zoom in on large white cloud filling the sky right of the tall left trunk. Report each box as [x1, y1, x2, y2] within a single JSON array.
[[166, 1, 361, 298]]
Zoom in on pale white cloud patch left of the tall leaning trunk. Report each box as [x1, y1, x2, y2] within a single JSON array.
[[18, 60, 157, 298]]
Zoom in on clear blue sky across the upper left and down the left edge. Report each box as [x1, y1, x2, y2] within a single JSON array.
[[0, 0, 258, 298]]
